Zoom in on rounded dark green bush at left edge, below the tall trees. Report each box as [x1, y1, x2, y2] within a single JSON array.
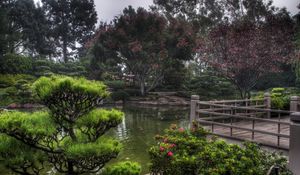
[[0, 54, 32, 74]]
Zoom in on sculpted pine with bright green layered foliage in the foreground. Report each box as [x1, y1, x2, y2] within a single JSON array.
[[0, 76, 123, 175]]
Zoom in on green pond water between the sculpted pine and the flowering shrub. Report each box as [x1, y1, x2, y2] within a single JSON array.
[[109, 106, 189, 173]]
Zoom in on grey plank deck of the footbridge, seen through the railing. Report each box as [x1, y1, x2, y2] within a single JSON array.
[[200, 117, 290, 150]]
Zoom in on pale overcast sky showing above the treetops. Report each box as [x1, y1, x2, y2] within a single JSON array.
[[94, 0, 299, 22]]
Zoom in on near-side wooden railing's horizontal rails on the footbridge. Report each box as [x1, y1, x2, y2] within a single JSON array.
[[196, 102, 290, 149]]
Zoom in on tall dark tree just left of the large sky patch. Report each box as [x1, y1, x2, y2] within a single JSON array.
[[42, 0, 97, 62]]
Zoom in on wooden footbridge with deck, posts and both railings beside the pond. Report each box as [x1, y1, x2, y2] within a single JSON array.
[[190, 94, 292, 150]]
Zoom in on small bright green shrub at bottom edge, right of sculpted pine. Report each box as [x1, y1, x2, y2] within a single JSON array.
[[102, 161, 141, 175]]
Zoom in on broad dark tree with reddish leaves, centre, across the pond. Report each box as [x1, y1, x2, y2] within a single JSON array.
[[92, 6, 195, 95]]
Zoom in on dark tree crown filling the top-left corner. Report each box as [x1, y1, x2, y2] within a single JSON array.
[[0, 0, 54, 56]]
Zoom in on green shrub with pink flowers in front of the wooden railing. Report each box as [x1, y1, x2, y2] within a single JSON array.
[[149, 125, 291, 175]]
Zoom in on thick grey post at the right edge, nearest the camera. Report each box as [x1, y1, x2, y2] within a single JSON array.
[[289, 112, 300, 174]]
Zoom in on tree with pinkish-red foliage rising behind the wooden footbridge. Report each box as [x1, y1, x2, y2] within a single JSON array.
[[200, 11, 293, 98]]
